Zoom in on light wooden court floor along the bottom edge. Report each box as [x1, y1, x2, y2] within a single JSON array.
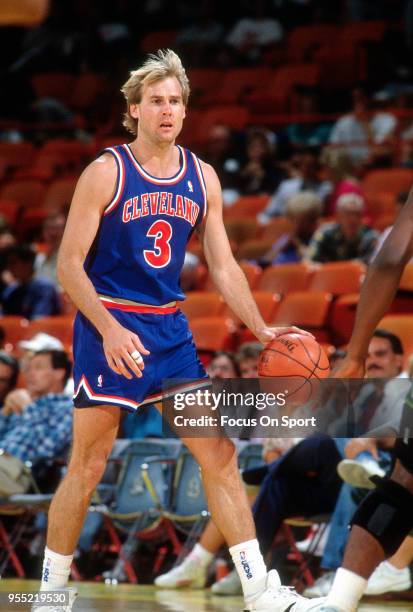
[[0, 580, 413, 612]]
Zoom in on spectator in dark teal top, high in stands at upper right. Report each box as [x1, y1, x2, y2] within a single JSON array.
[[285, 85, 331, 148]]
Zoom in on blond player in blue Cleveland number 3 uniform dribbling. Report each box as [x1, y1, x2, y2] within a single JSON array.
[[33, 50, 322, 612]]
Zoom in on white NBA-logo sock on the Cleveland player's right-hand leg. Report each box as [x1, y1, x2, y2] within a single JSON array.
[[229, 540, 267, 599]]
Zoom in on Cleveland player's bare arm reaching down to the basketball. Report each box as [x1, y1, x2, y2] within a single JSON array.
[[202, 163, 307, 344]]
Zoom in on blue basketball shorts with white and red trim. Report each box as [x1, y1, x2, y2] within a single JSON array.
[[73, 308, 208, 412]]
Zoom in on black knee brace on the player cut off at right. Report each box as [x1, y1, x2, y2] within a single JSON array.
[[352, 478, 413, 557]]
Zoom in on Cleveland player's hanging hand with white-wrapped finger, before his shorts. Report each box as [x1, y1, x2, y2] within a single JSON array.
[[102, 323, 149, 380]]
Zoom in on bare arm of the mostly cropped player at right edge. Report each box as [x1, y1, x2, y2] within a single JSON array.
[[335, 189, 413, 378]]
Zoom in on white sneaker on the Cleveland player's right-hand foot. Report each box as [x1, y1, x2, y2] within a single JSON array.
[[244, 570, 324, 612]]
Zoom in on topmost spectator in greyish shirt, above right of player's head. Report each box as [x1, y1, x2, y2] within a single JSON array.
[[226, 0, 283, 62]]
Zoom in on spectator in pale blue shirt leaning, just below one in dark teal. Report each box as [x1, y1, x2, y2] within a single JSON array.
[[257, 149, 331, 224]]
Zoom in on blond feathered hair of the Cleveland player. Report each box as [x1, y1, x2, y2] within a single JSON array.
[[121, 49, 189, 135]]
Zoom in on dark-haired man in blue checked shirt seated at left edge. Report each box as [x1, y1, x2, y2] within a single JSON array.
[[0, 351, 73, 495]]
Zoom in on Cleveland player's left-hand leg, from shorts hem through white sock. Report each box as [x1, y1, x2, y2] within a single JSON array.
[[36, 406, 120, 610]]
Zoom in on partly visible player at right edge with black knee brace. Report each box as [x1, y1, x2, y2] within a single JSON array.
[[310, 189, 413, 612]]
